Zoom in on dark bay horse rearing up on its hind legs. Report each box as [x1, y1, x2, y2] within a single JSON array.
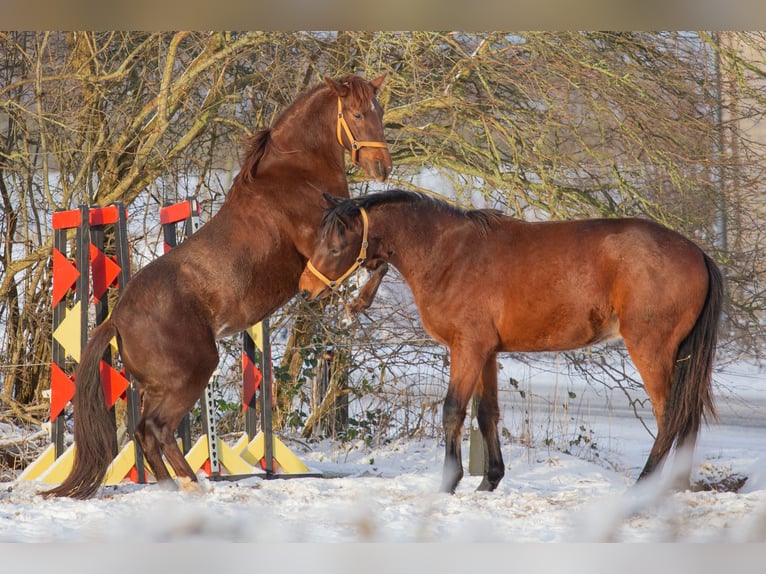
[[42, 74, 392, 499]]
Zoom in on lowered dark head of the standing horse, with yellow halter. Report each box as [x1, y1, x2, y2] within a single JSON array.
[[298, 194, 368, 299]]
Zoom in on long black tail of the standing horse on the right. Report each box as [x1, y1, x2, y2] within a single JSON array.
[[657, 254, 724, 472]]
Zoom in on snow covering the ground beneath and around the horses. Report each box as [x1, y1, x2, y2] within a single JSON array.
[[0, 362, 766, 544]]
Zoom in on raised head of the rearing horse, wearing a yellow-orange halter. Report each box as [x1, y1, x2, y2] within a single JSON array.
[[325, 74, 393, 181]]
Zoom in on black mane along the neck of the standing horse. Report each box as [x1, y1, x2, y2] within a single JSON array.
[[321, 189, 504, 236]]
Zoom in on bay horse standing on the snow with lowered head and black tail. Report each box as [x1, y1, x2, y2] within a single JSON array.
[[300, 190, 723, 493]]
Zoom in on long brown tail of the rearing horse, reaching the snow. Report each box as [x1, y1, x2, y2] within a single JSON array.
[[41, 320, 117, 499]]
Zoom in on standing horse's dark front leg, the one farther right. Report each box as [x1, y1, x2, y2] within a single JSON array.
[[477, 353, 505, 490]]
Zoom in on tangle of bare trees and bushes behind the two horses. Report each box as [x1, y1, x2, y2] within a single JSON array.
[[0, 31, 766, 450]]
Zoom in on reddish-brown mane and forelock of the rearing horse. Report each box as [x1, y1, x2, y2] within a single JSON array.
[[237, 75, 375, 184]]
